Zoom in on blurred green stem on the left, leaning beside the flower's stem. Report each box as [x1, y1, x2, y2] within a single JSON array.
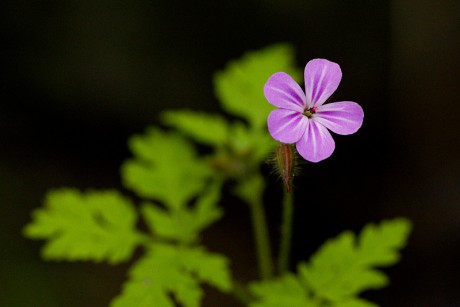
[[249, 197, 273, 279]]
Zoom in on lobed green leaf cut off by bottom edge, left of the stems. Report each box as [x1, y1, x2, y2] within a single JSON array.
[[111, 244, 231, 307]]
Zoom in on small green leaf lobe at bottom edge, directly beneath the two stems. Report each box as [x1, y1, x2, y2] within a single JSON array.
[[249, 274, 317, 307]]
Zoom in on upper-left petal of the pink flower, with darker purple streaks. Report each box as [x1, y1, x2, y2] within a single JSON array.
[[264, 72, 306, 112]]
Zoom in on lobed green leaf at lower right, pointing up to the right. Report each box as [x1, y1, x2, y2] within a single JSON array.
[[250, 218, 411, 307]]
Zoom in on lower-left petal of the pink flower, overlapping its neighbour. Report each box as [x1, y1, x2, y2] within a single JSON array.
[[267, 109, 308, 144]]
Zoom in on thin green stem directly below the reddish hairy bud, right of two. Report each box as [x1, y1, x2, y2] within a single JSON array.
[[278, 190, 294, 275]]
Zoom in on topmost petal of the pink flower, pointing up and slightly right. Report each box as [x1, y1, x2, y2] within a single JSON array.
[[304, 59, 342, 108]]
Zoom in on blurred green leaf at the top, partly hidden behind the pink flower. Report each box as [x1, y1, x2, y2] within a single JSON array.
[[214, 44, 300, 128]]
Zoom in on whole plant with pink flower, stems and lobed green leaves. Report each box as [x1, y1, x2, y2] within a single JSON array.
[[24, 45, 411, 307]]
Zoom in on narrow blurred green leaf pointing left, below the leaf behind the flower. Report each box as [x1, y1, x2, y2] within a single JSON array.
[[162, 110, 229, 146]]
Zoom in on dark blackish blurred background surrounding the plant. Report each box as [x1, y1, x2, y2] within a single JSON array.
[[0, 0, 460, 307]]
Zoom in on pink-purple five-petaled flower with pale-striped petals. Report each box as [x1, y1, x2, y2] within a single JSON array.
[[264, 59, 364, 162]]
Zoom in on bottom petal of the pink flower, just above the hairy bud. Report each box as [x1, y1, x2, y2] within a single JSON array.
[[296, 120, 335, 162]]
